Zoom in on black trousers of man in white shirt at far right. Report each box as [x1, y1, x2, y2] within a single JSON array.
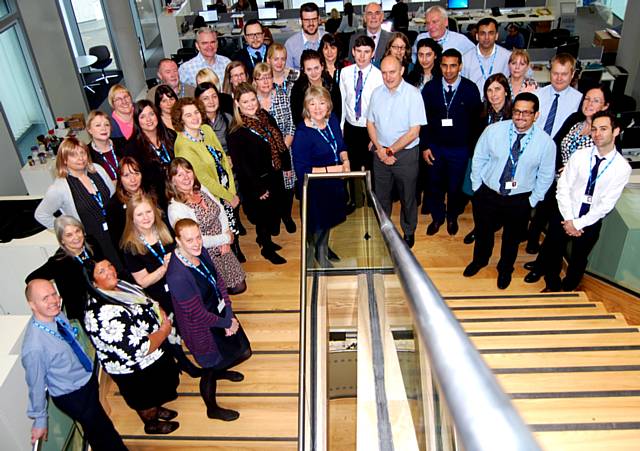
[[536, 207, 602, 291]]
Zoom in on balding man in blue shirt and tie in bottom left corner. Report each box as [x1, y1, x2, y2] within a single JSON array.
[[21, 279, 127, 451]]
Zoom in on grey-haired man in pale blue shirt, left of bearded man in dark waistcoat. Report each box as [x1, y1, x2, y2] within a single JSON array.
[[178, 27, 231, 86]]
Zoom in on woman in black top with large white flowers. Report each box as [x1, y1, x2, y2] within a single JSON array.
[[84, 260, 180, 434]]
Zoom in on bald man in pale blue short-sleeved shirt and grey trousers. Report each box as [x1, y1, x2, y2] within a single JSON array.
[[367, 56, 427, 251]]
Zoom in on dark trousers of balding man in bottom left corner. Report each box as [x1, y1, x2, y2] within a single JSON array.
[[51, 374, 127, 451]]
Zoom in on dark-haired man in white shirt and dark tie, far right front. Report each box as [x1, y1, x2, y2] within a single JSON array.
[[525, 111, 631, 292]]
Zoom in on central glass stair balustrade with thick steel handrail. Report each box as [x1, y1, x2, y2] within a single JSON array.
[[299, 173, 539, 451]]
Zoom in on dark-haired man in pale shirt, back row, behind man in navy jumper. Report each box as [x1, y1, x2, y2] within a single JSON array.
[[462, 17, 511, 98]]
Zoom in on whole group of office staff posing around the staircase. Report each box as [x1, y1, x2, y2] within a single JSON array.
[[23, 3, 630, 449]]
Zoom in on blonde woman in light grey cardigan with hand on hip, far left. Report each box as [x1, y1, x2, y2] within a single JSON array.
[[34, 137, 122, 270]]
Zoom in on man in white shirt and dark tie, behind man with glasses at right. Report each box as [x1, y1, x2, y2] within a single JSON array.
[[536, 53, 582, 138]]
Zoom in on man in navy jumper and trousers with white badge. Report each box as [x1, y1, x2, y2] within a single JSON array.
[[420, 49, 482, 235]]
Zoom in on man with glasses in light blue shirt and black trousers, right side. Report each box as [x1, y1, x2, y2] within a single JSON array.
[[463, 92, 555, 290]]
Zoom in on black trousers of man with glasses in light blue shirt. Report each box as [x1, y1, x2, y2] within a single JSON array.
[[472, 184, 531, 274]]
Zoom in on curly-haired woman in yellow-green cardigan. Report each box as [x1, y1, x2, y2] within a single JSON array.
[[171, 97, 246, 263]]
